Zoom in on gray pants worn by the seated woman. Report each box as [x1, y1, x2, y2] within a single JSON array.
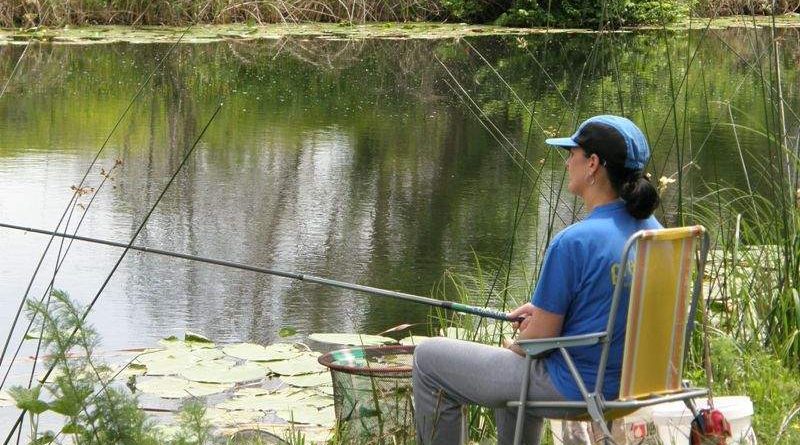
[[412, 338, 564, 445]]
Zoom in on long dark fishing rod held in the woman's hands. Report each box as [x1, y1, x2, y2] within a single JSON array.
[[0, 223, 522, 322]]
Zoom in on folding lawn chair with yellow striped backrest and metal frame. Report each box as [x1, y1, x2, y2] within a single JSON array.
[[508, 226, 709, 445]]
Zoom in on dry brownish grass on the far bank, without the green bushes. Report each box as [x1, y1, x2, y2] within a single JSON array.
[[0, 0, 800, 27]]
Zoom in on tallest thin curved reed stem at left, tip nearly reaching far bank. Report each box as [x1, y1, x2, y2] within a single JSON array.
[[0, 24, 200, 387]]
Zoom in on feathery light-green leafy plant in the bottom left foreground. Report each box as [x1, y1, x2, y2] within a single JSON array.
[[9, 290, 238, 445]]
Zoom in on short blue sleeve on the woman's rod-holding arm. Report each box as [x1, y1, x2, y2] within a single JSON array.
[[531, 237, 577, 315]]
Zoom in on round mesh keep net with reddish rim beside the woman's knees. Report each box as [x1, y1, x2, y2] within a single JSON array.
[[319, 346, 414, 444]]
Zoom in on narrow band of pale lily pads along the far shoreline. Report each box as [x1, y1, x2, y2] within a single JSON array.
[[0, 14, 800, 46]]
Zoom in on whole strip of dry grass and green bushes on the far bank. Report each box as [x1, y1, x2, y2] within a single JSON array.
[[0, 0, 800, 28]]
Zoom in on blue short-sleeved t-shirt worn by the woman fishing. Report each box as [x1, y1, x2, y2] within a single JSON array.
[[531, 200, 662, 400]]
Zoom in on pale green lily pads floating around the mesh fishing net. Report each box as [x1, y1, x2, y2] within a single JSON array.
[[119, 333, 428, 443]]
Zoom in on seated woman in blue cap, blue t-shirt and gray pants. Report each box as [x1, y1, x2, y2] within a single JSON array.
[[413, 115, 661, 444]]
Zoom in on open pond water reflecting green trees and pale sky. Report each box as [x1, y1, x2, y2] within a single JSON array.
[[0, 29, 800, 388]]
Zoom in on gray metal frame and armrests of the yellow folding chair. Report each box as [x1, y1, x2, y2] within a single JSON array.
[[507, 225, 709, 445]]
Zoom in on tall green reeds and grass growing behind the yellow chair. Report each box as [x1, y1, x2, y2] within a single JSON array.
[[422, 14, 800, 444]]
